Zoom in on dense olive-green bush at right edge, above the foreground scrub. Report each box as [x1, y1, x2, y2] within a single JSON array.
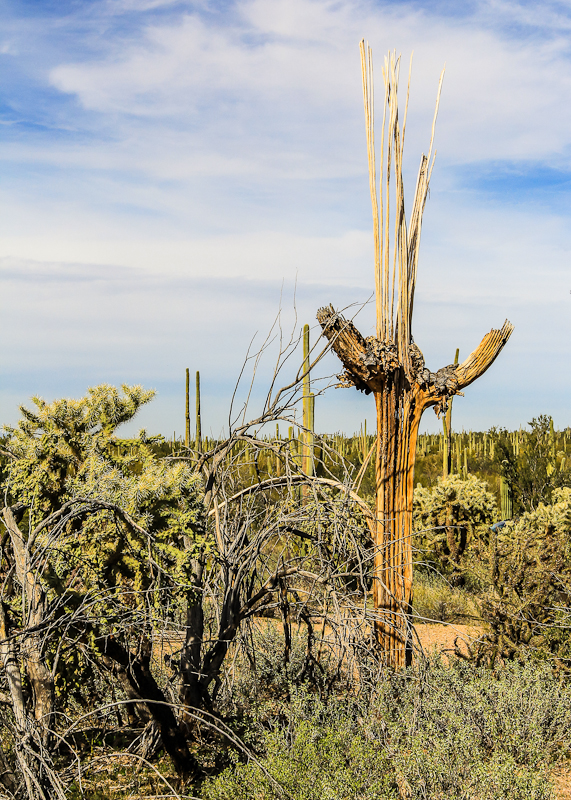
[[475, 488, 571, 671]]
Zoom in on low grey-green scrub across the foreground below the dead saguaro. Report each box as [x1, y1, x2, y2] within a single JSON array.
[[203, 659, 571, 800]]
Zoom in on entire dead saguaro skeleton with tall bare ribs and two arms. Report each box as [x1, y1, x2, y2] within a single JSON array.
[[317, 42, 513, 668]]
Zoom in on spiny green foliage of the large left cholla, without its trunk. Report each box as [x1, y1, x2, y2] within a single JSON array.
[[3, 385, 210, 703]]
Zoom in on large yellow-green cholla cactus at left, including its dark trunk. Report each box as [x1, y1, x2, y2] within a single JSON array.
[[0, 385, 209, 780]]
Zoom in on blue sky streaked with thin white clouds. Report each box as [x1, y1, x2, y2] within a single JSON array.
[[0, 0, 571, 436]]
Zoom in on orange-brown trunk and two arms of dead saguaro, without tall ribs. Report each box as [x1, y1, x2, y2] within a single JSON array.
[[317, 306, 513, 669]]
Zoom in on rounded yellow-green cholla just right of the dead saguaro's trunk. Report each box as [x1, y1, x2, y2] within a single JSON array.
[[413, 475, 497, 583]]
